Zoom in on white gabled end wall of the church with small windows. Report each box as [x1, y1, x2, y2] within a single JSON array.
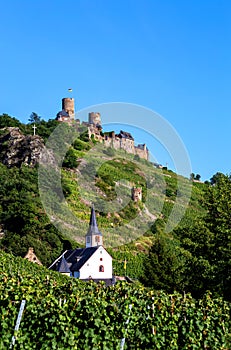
[[79, 246, 112, 279]]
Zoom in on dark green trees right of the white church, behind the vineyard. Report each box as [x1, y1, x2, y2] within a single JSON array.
[[146, 173, 231, 300]]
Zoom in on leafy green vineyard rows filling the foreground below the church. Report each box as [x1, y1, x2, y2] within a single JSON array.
[[0, 252, 231, 350]]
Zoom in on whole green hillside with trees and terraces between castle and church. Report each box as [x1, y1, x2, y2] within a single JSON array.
[[0, 115, 231, 299]]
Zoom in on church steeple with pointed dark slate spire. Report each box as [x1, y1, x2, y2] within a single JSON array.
[[85, 206, 103, 248]]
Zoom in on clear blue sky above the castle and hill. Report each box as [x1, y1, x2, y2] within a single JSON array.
[[0, 0, 231, 180]]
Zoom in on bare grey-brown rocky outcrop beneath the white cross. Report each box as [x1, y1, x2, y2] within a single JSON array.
[[0, 127, 45, 168]]
